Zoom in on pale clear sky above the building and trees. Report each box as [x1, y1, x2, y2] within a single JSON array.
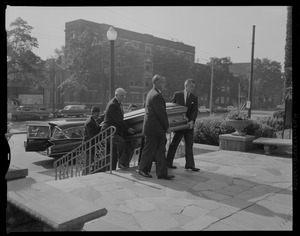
[[5, 6, 287, 67]]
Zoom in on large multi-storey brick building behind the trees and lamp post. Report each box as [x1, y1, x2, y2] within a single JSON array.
[[65, 19, 195, 107]]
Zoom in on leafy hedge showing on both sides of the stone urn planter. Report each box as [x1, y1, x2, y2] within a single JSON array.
[[194, 117, 283, 146]]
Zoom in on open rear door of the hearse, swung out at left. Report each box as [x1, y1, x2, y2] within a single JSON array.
[[24, 122, 53, 152]]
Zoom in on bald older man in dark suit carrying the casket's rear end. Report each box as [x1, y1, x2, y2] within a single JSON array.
[[102, 88, 135, 170]]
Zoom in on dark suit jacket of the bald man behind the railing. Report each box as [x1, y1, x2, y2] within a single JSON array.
[[102, 98, 129, 136]]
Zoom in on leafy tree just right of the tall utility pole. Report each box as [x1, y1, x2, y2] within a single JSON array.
[[253, 58, 284, 108]]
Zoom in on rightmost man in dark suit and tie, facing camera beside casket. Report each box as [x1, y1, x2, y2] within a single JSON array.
[[167, 79, 200, 171]]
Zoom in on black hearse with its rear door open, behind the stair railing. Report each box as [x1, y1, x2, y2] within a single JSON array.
[[24, 119, 85, 157]]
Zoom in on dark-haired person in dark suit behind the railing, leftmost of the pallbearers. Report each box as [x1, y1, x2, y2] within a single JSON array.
[[83, 106, 101, 174]]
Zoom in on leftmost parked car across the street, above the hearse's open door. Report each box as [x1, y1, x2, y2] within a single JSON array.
[[10, 106, 50, 121]]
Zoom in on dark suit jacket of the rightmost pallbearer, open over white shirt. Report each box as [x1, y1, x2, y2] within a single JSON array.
[[171, 91, 198, 123]]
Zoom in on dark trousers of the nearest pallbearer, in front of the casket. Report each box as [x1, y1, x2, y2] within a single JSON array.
[[139, 135, 168, 177]]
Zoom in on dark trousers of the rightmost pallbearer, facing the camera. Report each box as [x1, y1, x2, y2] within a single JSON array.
[[167, 129, 195, 168]]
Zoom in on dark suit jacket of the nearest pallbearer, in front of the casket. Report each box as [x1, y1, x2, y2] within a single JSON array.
[[143, 88, 169, 136]]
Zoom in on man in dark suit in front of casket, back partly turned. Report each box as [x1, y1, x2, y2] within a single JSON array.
[[139, 75, 175, 180]]
